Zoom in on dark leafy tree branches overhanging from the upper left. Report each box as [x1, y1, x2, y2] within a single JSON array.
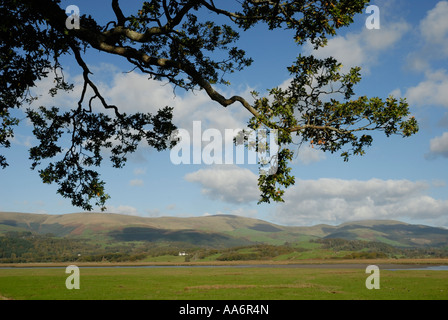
[[0, 0, 418, 209]]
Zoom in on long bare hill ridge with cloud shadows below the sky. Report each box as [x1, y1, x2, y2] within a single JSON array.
[[0, 212, 448, 247]]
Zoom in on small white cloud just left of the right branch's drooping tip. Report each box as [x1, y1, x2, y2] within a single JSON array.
[[185, 165, 259, 203]]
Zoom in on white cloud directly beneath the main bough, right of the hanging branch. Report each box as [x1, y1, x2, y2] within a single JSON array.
[[101, 72, 250, 131]]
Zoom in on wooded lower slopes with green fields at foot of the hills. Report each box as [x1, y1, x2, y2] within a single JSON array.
[[0, 232, 448, 263]]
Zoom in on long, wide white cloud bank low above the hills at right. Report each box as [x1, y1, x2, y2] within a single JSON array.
[[275, 179, 448, 225]]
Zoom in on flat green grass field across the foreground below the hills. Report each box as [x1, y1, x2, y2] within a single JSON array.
[[0, 266, 448, 300]]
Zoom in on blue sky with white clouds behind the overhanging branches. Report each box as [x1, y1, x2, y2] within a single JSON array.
[[0, 0, 448, 227]]
